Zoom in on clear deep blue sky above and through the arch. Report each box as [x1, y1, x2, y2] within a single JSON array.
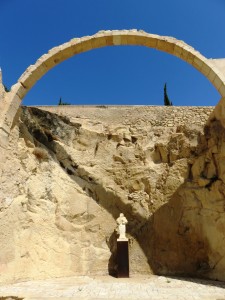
[[0, 0, 225, 105]]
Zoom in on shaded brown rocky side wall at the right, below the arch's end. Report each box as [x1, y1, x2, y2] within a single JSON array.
[[151, 119, 225, 280]]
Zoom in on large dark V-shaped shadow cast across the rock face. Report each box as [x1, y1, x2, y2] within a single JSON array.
[[20, 108, 225, 279]]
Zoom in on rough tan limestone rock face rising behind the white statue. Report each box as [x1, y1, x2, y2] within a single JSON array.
[[0, 107, 225, 281]]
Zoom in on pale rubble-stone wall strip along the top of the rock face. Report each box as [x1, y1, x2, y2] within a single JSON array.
[[35, 105, 214, 127]]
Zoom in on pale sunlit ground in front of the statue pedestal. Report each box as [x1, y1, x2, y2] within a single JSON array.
[[0, 275, 225, 300]]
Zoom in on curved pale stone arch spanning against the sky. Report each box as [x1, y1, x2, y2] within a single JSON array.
[[0, 30, 225, 143]]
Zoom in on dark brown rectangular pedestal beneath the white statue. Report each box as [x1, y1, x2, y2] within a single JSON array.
[[117, 238, 129, 278]]
